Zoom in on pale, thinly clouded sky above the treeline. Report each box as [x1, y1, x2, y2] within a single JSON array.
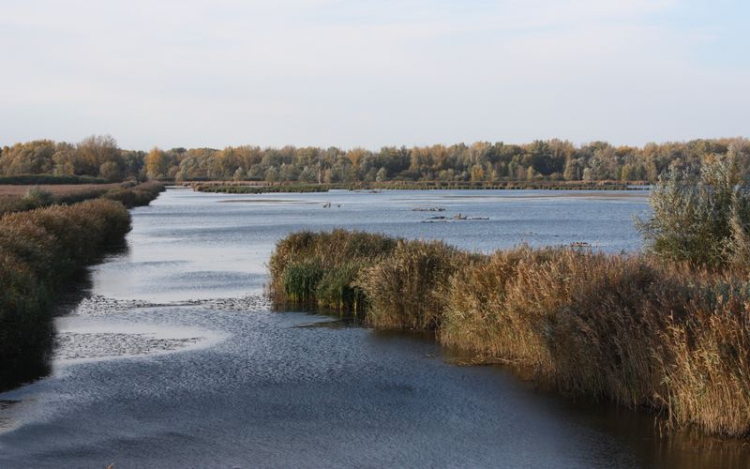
[[0, 0, 750, 150]]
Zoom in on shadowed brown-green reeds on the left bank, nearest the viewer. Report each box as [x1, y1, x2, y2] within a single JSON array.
[[0, 199, 130, 389]]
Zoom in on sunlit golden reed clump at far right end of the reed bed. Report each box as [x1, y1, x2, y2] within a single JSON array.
[[659, 277, 750, 437]]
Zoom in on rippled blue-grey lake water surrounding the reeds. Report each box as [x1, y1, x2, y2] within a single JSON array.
[[0, 189, 750, 469]]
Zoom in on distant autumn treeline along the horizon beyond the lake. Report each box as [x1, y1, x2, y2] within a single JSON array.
[[0, 136, 750, 184]]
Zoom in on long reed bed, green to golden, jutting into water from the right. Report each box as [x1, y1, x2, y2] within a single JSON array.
[[269, 230, 750, 438]]
